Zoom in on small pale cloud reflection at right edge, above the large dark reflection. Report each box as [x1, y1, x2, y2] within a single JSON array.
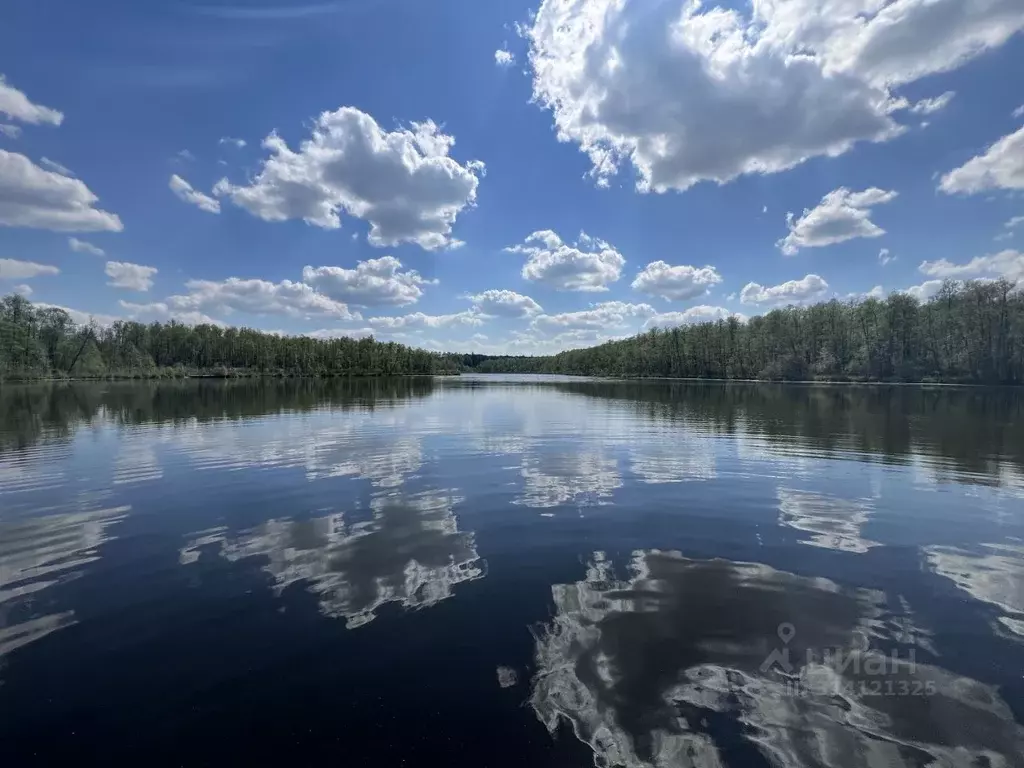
[[925, 544, 1024, 638]]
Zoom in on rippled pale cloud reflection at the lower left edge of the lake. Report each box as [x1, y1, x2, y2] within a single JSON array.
[[0, 507, 129, 656]]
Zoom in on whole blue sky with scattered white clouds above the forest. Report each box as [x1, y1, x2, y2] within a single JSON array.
[[0, 0, 1024, 353]]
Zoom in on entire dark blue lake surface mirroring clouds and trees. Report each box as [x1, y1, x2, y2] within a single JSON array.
[[0, 377, 1024, 768]]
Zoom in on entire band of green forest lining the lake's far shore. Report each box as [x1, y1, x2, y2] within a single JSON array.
[[6, 281, 1024, 384]]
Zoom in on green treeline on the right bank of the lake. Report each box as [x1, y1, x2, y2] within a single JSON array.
[[475, 280, 1024, 384]]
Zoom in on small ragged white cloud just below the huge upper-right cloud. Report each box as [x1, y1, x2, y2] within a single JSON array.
[[775, 186, 896, 256]]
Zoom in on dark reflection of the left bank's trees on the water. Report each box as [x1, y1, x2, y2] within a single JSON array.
[[0, 377, 435, 451]]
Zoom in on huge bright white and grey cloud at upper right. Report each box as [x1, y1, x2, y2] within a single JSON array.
[[527, 0, 1024, 191]]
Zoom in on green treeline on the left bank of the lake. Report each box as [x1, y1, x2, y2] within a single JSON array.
[[0, 295, 463, 380]]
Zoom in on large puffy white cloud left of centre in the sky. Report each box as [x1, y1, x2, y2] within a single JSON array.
[[214, 106, 484, 251]]
